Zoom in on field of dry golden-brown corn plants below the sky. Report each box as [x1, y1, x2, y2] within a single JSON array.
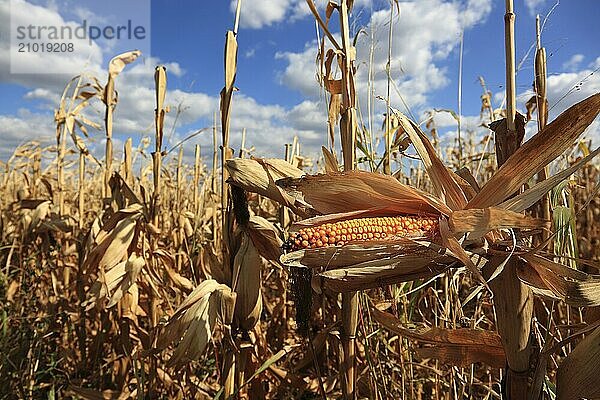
[[0, 0, 600, 399]]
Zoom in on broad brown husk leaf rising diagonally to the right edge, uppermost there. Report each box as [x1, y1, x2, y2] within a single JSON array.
[[466, 93, 600, 208]]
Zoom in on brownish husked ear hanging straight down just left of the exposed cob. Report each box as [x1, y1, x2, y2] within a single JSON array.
[[232, 232, 262, 331]]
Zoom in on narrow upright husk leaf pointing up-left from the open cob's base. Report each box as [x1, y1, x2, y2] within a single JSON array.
[[394, 112, 467, 210]]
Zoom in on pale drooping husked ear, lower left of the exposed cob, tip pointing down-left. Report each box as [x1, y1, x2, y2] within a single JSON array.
[[156, 279, 235, 365]]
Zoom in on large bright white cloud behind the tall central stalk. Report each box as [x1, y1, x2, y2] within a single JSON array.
[[276, 0, 492, 129]]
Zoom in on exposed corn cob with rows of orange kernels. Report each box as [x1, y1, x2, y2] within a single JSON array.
[[284, 215, 438, 251]]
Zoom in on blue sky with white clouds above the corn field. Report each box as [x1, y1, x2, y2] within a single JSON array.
[[0, 0, 600, 160]]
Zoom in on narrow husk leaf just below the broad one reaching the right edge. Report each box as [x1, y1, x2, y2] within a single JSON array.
[[498, 147, 600, 212]]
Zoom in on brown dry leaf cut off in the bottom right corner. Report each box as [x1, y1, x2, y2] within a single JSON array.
[[556, 328, 600, 400]]
